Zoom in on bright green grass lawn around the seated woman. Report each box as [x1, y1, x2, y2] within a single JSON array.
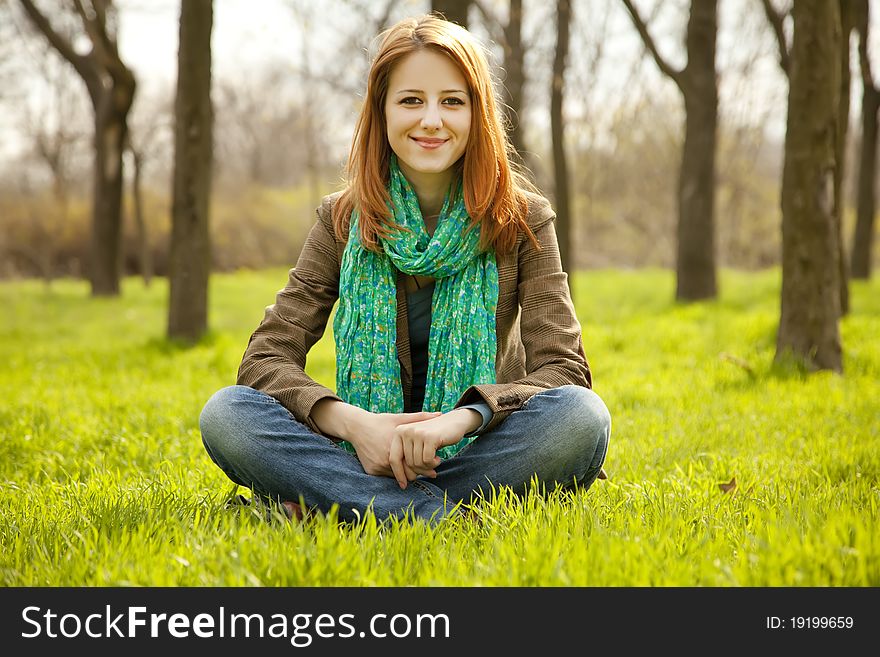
[[0, 270, 880, 586]]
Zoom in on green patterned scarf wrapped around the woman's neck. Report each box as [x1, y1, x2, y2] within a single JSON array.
[[333, 155, 498, 458]]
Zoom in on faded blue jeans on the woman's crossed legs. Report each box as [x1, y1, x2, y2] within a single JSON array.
[[199, 385, 611, 523]]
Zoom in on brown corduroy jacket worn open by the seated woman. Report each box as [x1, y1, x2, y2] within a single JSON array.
[[238, 193, 592, 432]]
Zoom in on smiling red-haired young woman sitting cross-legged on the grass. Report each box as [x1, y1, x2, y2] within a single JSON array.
[[200, 15, 611, 522]]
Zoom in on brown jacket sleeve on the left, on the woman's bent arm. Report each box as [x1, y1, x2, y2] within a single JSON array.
[[237, 199, 339, 433]]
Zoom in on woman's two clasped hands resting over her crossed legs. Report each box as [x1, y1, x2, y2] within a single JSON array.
[[351, 408, 482, 488]]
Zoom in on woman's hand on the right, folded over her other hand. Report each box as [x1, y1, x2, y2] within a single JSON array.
[[389, 408, 483, 488]]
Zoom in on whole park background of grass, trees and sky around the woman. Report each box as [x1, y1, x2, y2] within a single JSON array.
[[0, 0, 880, 586]]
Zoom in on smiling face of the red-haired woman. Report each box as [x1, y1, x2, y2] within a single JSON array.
[[385, 50, 471, 181]]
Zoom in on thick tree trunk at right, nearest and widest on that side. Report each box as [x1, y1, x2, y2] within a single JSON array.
[[776, 0, 843, 372]]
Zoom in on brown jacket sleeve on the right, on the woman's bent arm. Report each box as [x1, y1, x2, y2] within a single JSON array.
[[456, 202, 592, 431]]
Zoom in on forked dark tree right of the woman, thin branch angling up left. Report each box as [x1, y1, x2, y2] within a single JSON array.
[[623, 0, 718, 301]]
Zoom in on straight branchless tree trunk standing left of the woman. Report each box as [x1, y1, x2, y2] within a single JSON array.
[[168, 0, 213, 342]]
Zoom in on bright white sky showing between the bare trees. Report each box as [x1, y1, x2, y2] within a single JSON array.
[[0, 0, 880, 172]]
